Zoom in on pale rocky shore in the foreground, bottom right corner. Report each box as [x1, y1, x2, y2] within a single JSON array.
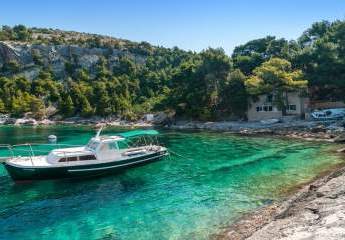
[[213, 163, 345, 240]]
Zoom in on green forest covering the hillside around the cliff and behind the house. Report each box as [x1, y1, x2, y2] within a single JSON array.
[[0, 20, 345, 120]]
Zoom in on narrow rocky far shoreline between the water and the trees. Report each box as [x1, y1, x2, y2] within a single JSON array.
[[1, 118, 345, 143]]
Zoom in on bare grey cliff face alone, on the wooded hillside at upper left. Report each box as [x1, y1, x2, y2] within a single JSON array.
[[0, 41, 146, 80]]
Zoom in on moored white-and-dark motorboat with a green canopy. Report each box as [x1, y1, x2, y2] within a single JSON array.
[[4, 129, 168, 181]]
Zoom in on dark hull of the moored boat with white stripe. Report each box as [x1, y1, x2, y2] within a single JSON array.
[[4, 150, 168, 181]]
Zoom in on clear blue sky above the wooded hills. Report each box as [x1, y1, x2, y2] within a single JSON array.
[[0, 0, 345, 54]]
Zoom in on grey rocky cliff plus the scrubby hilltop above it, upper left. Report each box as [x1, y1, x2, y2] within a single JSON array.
[[0, 29, 154, 80]]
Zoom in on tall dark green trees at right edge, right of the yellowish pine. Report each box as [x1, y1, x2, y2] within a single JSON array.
[[294, 21, 345, 100]]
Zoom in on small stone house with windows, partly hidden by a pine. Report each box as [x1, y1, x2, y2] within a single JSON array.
[[247, 91, 309, 121]]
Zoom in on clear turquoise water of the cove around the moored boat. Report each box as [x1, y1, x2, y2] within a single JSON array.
[[0, 127, 342, 240]]
